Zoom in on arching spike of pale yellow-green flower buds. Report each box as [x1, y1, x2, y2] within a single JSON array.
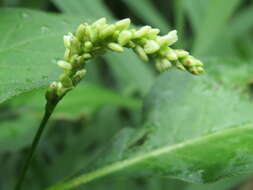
[[47, 18, 204, 99]]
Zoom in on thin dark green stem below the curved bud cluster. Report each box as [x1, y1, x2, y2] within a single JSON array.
[[15, 99, 60, 190]]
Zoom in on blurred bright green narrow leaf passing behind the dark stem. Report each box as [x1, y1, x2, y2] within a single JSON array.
[[11, 82, 142, 119]]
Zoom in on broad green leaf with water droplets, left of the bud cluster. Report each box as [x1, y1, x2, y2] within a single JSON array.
[[0, 9, 88, 103]]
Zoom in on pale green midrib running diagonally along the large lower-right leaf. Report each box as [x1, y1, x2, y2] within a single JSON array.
[[46, 122, 253, 190]]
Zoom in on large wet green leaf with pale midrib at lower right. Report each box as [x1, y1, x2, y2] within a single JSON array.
[[48, 71, 253, 190]]
